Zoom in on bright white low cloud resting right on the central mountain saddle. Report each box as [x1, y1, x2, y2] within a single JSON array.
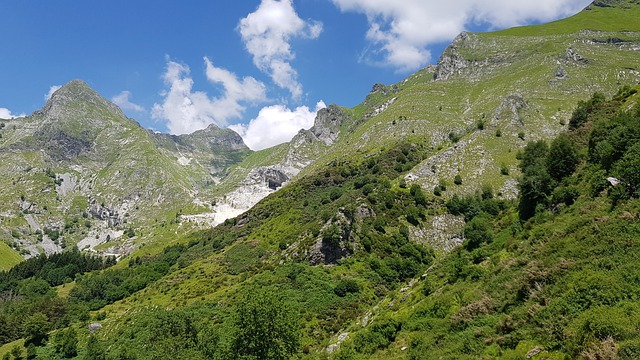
[[229, 101, 326, 150]]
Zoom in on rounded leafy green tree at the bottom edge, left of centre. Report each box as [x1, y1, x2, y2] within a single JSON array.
[[232, 289, 300, 359]]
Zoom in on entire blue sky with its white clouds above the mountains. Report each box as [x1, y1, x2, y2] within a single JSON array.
[[0, 0, 589, 149]]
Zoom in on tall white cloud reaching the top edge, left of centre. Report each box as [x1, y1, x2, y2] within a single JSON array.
[[238, 0, 322, 98]]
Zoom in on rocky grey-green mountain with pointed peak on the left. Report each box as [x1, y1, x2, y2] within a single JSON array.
[[0, 80, 251, 262]]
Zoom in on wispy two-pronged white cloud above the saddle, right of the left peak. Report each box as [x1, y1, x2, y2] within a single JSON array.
[[151, 57, 266, 134]]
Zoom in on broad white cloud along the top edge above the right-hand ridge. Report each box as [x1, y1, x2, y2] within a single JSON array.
[[331, 0, 591, 72]]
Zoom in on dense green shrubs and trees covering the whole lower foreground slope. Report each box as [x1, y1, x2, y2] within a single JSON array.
[[0, 87, 640, 359]]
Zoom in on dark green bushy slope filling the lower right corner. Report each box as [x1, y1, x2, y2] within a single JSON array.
[[330, 87, 640, 359]]
